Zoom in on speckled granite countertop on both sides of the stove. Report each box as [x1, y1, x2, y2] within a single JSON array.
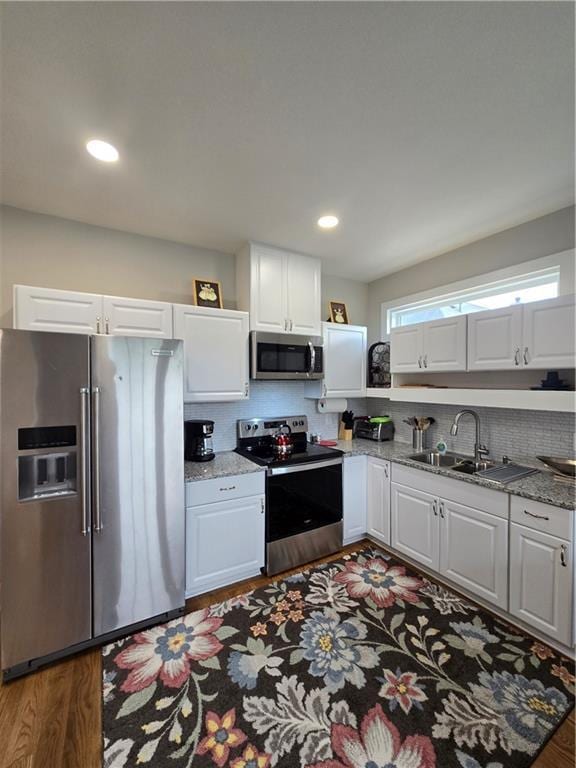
[[184, 439, 576, 509]]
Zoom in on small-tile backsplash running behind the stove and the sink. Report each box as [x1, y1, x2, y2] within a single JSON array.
[[184, 388, 576, 459]]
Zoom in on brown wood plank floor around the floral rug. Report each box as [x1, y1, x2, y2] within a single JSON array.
[[0, 542, 576, 768]]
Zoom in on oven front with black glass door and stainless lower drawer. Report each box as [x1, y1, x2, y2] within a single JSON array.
[[266, 458, 342, 575]]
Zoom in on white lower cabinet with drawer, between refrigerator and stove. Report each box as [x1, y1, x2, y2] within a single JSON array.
[[186, 472, 266, 597]]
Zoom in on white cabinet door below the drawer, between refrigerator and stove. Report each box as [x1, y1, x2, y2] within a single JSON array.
[[186, 496, 266, 597]]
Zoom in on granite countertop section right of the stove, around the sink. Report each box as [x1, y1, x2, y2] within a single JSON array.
[[337, 439, 576, 509]]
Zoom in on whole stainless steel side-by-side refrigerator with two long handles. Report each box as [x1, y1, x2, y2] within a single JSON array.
[[0, 330, 185, 679]]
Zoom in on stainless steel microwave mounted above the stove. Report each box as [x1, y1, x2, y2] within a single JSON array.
[[250, 331, 324, 381]]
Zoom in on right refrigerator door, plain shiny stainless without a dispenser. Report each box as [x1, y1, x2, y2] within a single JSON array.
[[91, 336, 185, 636]]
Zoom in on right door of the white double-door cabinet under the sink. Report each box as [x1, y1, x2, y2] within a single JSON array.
[[439, 499, 508, 610]]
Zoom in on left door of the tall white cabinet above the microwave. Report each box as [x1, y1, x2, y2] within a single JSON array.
[[250, 245, 288, 333]]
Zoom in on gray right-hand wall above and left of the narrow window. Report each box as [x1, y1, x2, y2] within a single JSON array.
[[368, 206, 574, 341]]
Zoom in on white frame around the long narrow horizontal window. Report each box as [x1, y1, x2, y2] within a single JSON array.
[[380, 248, 576, 341]]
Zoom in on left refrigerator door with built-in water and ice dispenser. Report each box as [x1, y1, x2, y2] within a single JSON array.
[[0, 330, 92, 670]]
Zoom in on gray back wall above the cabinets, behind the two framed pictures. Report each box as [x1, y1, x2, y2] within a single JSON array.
[[0, 206, 368, 327]]
